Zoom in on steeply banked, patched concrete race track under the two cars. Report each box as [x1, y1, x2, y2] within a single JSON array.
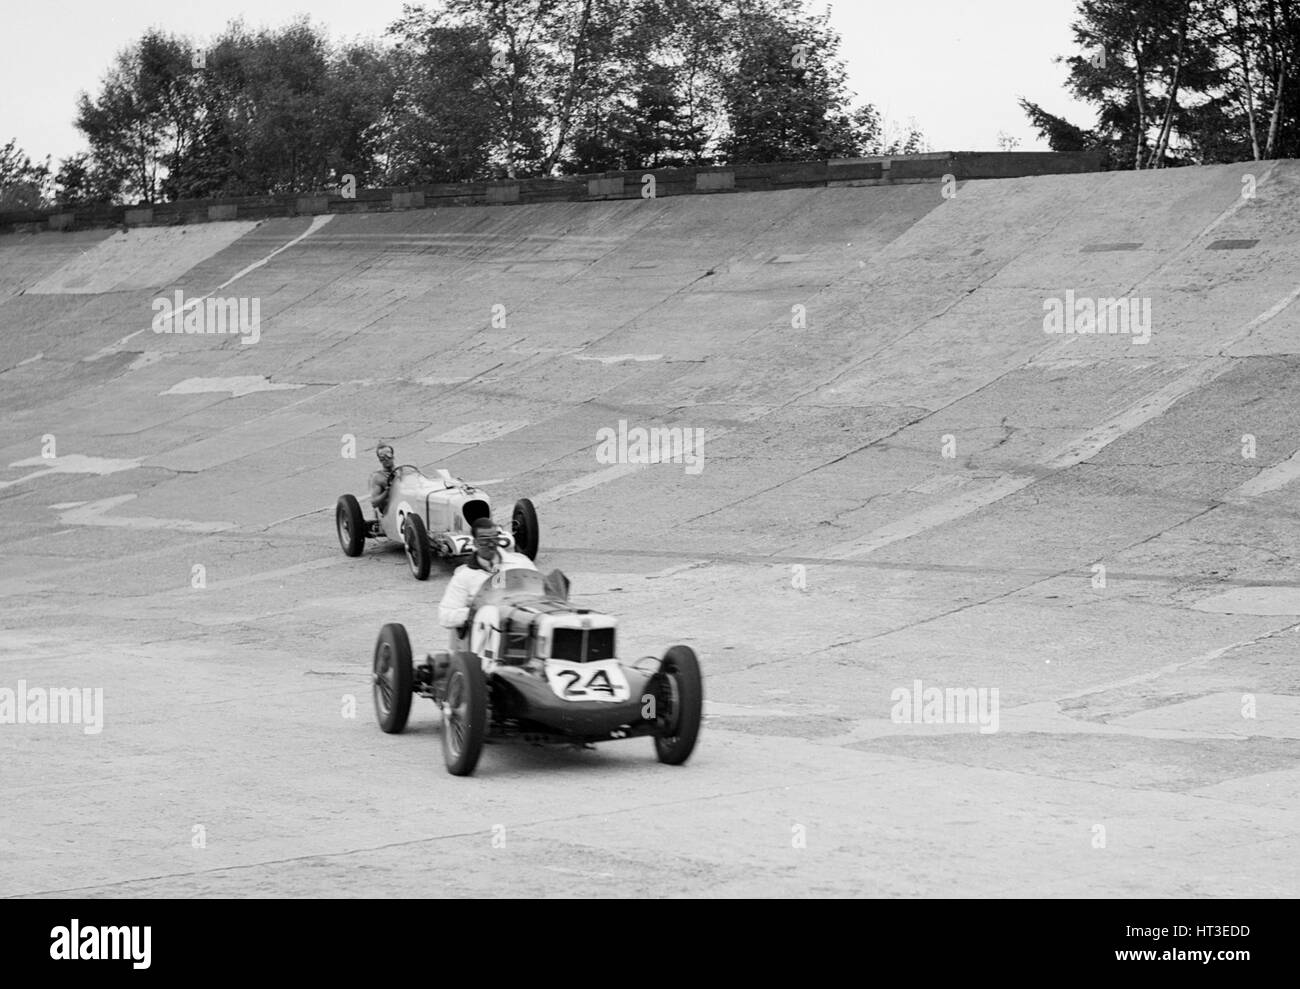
[[0, 162, 1300, 897]]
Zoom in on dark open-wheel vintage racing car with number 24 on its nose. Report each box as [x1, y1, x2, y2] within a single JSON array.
[[372, 568, 703, 776]]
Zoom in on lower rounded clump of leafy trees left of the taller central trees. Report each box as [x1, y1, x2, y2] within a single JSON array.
[[69, 18, 395, 201]]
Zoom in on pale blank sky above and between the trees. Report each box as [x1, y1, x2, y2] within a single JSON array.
[[0, 0, 1093, 165]]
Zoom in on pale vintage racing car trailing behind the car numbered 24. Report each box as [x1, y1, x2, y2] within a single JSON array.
[[334, 464, 540, 581]]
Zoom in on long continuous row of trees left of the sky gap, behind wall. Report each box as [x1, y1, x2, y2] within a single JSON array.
[[0, 0, 924, 208]]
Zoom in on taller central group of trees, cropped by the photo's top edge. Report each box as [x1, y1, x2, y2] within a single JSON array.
[[379, 0, 904, 177]]
